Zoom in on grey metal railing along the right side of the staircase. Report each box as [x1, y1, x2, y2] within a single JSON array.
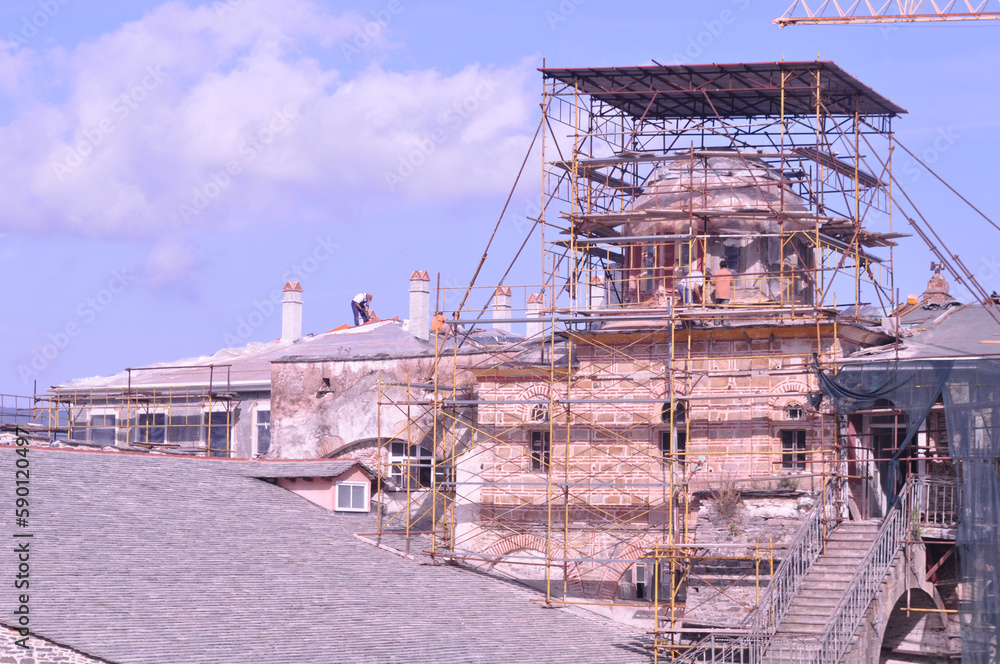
[[813, 478, 914, 664]]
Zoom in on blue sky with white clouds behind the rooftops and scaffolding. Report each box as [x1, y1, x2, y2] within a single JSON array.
[[0, 0, 1000, 395]]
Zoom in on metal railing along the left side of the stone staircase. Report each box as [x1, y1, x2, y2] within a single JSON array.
[[674, 479, 841, 664]]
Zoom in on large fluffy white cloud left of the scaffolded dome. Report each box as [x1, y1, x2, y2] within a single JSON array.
[[0, 0, 535, 239]]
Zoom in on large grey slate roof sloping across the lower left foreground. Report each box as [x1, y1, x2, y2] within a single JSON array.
[[0, 448, 649, 664]]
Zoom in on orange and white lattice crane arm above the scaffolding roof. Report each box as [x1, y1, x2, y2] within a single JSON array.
[[774, 0, 1000, 28]]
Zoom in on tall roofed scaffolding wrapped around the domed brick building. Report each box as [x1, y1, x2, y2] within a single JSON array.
[[368, 62, 961, 661]]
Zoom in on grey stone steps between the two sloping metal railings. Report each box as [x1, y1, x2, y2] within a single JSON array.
[[775, 521, 879, 640]]
